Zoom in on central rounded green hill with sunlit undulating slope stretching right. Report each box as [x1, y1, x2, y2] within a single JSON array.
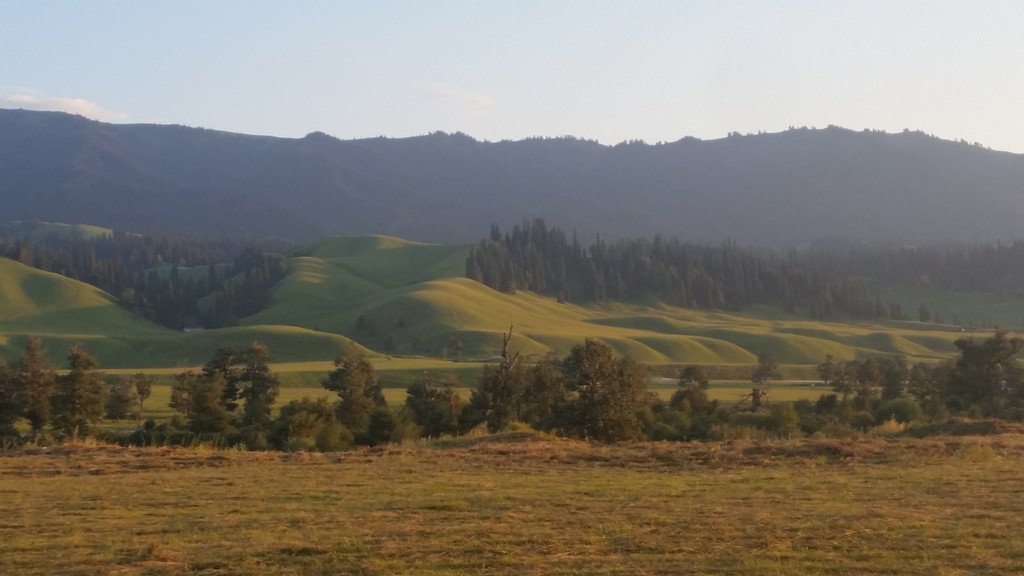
[[247, 237, 959, 364]]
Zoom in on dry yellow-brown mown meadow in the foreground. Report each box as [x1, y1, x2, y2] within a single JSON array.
[[0, 433, 1024, 575]]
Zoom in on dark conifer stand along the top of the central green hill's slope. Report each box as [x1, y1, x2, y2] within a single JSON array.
[[466, 219, 905, 319]]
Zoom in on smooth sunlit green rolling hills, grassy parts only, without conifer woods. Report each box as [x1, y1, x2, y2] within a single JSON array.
[[0, 237, 963, 369]]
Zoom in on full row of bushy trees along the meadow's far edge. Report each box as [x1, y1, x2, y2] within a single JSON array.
[[0, 331, 1024, 451]]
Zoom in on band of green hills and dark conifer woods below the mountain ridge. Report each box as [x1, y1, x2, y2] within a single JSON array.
[[6, 220, 1021, 366]]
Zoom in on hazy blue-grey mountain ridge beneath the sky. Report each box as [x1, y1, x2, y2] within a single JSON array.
[[0, 110, 1024, 245]]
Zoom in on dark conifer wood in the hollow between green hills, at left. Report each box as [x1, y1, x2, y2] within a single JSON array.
[[0, 231, 287, 330]]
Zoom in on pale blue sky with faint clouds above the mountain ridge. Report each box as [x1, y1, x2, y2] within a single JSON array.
[[0, 0, 1024, 153]]
